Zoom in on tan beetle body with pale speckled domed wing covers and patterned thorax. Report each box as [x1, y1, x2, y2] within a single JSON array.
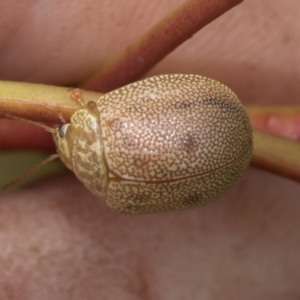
[[54, 74, 252, 214]]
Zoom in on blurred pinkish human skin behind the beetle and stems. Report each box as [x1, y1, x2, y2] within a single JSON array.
[[0, 0, 300, 300]]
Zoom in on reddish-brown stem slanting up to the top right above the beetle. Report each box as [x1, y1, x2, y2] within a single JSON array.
[[80, 0, 242, 93]]
